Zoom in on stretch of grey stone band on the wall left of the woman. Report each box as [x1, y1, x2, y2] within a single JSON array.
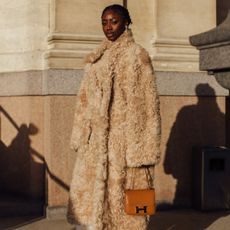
[[0, 69, 83, 96]]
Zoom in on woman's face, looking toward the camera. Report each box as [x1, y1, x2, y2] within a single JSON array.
[[102, 10, 127, 41]]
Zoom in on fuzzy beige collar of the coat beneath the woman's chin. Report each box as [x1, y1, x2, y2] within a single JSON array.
[[85, 29, 134, 64]]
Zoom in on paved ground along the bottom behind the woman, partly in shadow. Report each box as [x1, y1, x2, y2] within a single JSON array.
[[0, 210, 230, 230]]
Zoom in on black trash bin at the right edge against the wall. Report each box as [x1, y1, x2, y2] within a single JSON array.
[[192, 147, 230, 211]]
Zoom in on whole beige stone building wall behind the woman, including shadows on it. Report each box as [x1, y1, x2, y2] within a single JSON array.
[[0, 0, 228, 215]]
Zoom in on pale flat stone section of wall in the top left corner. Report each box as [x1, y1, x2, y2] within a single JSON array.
[[0, 0, 49, 72]]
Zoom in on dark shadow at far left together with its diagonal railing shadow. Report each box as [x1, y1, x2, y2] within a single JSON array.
[[0, 106, 69, 229]]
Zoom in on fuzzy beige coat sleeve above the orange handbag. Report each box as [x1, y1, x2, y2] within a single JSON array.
[[126, 48, 161, 167]]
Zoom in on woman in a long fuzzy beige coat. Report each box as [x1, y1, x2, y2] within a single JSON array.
[[68, 5, 160, 230]]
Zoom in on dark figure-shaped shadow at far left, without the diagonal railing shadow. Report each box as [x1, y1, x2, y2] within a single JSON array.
[[0, 124, 44, 198]]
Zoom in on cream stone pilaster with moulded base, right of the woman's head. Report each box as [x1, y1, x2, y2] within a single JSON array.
[[127, 0, 216, 72]]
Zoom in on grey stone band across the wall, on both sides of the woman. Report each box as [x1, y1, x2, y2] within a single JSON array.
[[0, 69, 228, 96]]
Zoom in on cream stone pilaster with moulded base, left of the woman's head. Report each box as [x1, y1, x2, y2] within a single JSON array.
[[45, 0, 123, 69]]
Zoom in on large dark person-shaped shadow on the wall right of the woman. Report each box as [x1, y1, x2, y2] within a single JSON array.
[[148, 84, 225, 230]]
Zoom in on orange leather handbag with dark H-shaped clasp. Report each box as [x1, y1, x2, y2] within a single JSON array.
[[125, 168, 156, 216]]
